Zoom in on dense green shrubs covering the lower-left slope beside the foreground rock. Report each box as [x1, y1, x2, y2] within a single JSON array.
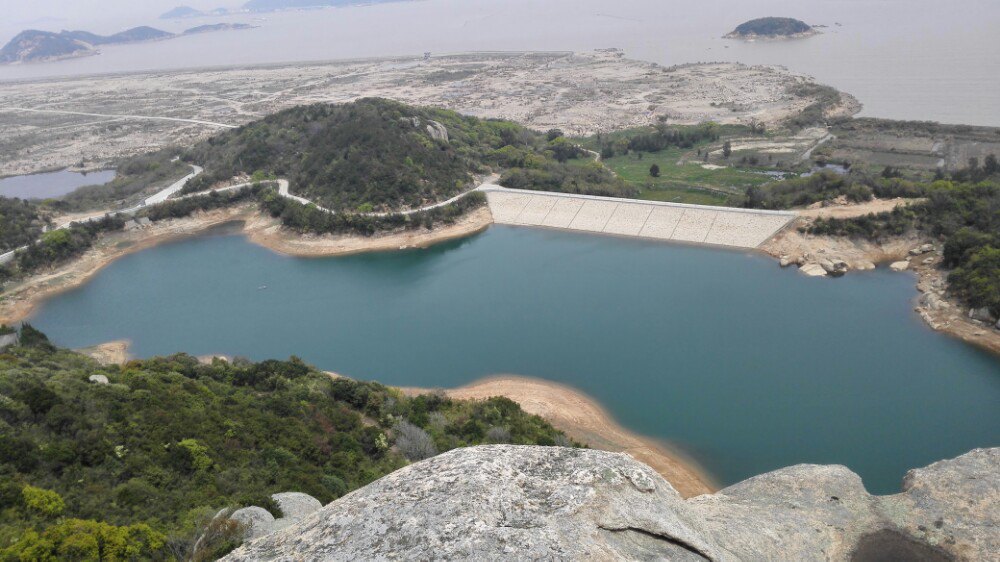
[[0, 326, 569, 560]]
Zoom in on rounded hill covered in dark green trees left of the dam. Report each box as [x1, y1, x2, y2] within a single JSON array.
[[185, 99, 615, 212]]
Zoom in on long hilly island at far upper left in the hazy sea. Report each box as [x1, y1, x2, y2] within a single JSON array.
[[0, 23, 252, 64]]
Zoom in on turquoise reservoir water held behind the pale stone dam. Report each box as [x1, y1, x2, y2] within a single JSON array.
[[32, 227, 1000, 493]]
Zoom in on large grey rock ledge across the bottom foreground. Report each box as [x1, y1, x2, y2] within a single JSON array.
[[225, 445, 1000, 561]]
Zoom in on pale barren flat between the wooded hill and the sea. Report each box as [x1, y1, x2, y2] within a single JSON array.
[[0, 50, 860, 176]]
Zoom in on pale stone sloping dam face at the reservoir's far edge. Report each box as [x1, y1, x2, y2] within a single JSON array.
[[483, 186, 795, 248]]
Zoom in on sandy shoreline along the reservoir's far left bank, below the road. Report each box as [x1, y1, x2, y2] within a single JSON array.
[[0, 204, 492, 324]]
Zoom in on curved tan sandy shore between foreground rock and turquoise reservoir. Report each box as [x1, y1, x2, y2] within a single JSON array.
[[400, 375, 719, 498]]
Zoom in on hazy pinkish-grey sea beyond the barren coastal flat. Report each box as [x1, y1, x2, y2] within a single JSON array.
[[0, 0, 1000, 126]]
